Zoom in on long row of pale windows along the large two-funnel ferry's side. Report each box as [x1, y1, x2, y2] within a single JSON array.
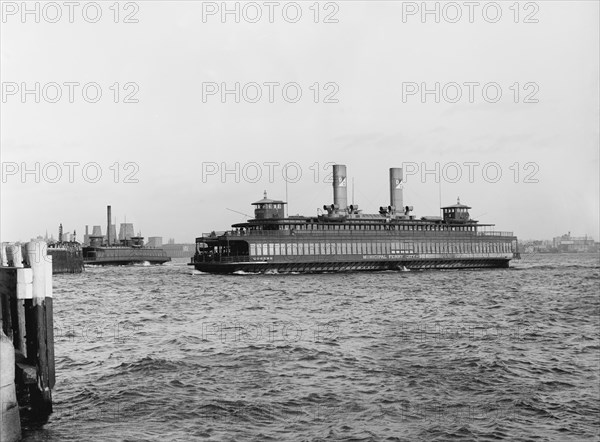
[[250, 241, 512, 256]]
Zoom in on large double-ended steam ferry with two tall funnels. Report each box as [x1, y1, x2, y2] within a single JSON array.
[[190, 165, 518, 273]]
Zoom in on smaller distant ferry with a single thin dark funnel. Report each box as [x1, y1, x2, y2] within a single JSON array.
[[82, 206, 171, 265]]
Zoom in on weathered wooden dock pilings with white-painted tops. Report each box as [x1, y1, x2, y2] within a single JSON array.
[[0, 241, 55, 442]]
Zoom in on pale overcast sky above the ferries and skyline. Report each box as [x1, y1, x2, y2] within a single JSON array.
[[0, 1, 600, 242]]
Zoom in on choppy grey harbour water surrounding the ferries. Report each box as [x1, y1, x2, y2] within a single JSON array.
[[25, 255, 600, 441]]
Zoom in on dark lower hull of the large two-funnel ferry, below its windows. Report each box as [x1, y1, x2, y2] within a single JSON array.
[[192, 258, 510, 274]]
